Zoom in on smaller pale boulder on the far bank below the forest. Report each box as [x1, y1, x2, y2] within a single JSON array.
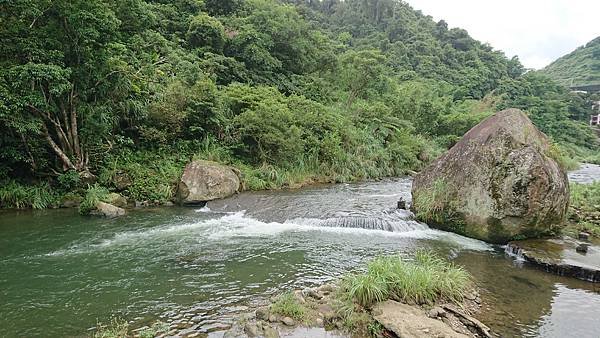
[[177, 161, 240, 204]]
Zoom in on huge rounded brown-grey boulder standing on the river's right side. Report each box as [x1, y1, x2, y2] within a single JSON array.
[[412, 109, 569, 243]]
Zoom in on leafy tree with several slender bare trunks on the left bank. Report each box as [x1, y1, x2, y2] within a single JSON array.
[[0, 0, 120, 175]]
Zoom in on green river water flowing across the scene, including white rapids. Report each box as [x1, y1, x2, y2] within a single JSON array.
[[0, 165, 600, 337]]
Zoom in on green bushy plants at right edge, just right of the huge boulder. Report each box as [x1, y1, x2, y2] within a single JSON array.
[[565, 182, 600, 238]]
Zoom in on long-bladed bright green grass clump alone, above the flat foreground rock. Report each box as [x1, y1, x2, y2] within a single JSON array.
[[342, 251, 471, 307]]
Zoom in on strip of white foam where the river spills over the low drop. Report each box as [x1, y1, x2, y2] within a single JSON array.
[[46, 210, 491, 256]]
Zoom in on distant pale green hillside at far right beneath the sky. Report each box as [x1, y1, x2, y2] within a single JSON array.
[[543, 36, 600, 87]]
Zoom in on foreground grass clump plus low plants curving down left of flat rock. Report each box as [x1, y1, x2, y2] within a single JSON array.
[[333, 251, 472, 337]]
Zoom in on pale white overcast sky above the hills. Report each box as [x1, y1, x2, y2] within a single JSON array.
[[405, 0, 600, 69]]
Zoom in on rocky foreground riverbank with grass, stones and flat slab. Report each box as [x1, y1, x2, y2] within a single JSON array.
[[119, 251, 491, 338]]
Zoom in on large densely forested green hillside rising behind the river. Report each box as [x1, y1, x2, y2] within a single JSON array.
[[0, 0, 598, 207]]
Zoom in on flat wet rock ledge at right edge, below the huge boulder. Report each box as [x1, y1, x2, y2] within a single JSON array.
[[506, 238, 600, 283]]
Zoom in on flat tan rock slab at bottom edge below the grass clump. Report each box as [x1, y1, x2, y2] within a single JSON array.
[[372, 300, 469, 338]]
